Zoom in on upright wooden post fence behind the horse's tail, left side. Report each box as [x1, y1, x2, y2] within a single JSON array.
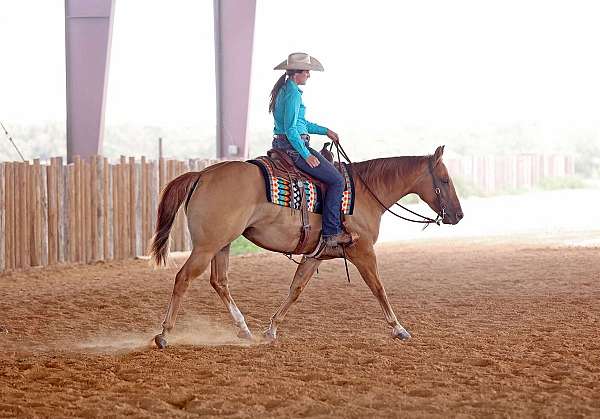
[[0, 156, 215, 271]]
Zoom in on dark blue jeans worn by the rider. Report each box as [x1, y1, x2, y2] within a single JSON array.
[[273, 140, 346, 236]]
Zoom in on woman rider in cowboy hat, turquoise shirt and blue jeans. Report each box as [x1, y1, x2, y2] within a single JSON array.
[[269, 52, 352, 247]]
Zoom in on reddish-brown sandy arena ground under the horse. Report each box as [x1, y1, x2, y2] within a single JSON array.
[[0, 234, 600, 418]]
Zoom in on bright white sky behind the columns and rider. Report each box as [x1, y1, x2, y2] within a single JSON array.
[[0, 0, 600, 132]]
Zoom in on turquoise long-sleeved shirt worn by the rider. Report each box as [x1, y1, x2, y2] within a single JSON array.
[[273, 79, 327, 159]]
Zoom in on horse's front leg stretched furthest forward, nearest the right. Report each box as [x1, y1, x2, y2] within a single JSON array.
[[348, 245, 410, 340]]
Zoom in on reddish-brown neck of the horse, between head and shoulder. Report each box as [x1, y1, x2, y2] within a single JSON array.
[[355, 156, 427, 207]]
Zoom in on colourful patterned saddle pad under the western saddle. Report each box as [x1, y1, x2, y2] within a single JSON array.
[[248, 156, 355, 215]]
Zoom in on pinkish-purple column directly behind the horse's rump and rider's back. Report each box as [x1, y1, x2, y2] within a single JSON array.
[[213, 0, 256, 159]]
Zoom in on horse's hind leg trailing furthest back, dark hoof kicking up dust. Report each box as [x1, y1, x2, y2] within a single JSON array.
[[154, 250, 213, 349]]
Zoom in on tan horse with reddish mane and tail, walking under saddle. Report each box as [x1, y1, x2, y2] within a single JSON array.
[[151, 147, 463, 348]]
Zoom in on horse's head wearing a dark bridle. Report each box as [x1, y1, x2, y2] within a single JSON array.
[[416, 146, 464, 224]]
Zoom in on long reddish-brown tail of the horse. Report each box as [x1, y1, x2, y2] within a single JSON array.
[[150, 172, 200, 266]]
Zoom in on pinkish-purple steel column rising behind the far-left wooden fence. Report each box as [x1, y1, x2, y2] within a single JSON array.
[[65, 0, 114, 161]]
